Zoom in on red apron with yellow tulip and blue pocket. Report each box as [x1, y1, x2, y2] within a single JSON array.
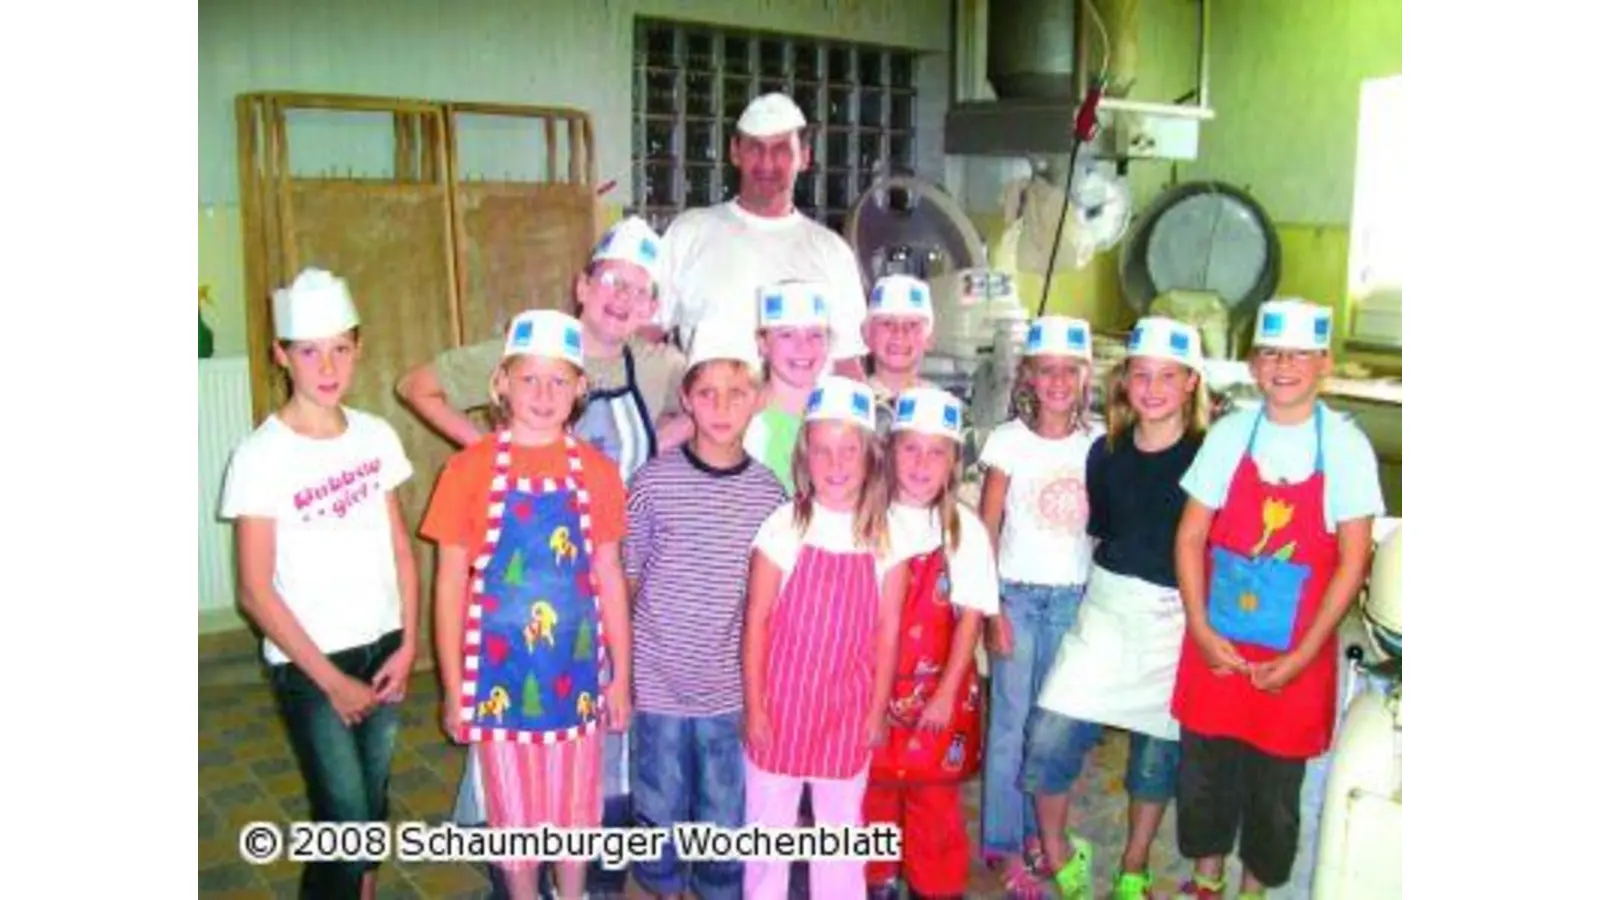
[[1173, 404, 1339, 759]]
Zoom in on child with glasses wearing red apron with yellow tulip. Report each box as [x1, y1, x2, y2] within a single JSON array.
[[1173, 301, 1382, 900]]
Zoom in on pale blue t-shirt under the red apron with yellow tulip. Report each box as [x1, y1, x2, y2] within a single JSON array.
[[1179, 405, 1384, 532]]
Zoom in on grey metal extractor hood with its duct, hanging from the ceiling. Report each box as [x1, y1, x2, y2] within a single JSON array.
[[944, 0, 1214, 159]]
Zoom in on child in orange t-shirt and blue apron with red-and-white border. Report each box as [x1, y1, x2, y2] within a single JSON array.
[[422, 309, 632, 900]]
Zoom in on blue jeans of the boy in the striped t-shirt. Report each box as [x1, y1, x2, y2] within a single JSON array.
[[632, 711, 744, 900]]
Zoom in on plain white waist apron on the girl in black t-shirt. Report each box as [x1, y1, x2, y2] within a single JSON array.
[[1040, 565, 1184, 740]]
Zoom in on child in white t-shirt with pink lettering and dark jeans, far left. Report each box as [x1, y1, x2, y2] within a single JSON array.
[[221, 269, 418, 898]]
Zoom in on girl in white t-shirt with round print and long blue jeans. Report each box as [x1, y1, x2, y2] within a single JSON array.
[[979, 315, 1101, 895]]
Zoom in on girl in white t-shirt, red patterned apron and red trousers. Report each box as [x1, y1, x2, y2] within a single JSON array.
[[866, 388, 1000, 898]]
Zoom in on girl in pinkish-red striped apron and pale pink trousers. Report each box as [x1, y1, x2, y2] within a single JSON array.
[[744, 376, 906, 900]]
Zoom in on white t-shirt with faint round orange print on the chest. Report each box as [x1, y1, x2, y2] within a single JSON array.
[[978, 420, 1104, 586]]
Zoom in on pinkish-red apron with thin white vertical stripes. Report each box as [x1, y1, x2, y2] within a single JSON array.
[[750, 534, 878, 778]]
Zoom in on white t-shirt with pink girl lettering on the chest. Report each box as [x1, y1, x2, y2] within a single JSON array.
[[221, 408, 411, 665]]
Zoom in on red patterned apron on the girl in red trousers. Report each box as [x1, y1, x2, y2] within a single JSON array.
[[872, 549, 982, 785]]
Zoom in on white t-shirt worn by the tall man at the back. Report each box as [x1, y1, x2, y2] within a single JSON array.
[[656, 200, 867, 360]]
